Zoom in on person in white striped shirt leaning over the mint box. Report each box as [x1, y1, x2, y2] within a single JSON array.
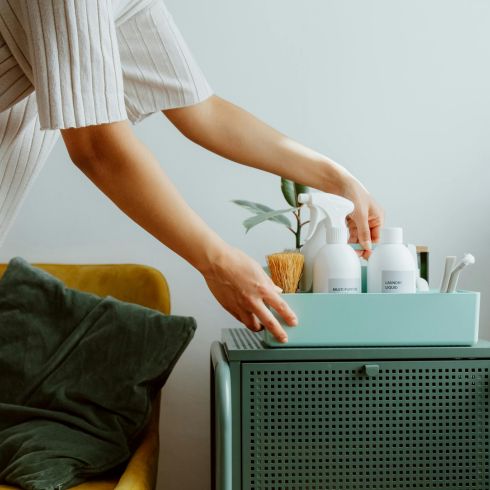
[[0, 0, 382, 342]]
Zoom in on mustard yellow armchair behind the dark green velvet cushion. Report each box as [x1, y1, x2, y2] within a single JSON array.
[[0, 264, 170, 490]]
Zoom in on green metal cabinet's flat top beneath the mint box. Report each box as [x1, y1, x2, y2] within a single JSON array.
[[222, 328, 490, 362]]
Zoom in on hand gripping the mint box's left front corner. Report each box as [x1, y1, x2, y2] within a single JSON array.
[[203, 247, 297, 342]]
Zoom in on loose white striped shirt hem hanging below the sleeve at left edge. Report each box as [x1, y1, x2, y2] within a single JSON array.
[[0, 94, 59, 246]]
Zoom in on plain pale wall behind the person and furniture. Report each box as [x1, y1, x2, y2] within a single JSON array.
[[0, 0, 490, 490]]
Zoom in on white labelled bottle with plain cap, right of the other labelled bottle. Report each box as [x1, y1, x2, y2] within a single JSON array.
[[367, 228, 417, 294]]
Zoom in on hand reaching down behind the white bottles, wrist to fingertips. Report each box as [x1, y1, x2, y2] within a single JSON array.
[[342, 176, 384, 259]]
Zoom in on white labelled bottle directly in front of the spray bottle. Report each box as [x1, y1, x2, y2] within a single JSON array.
[[313, 222, 361, 294]]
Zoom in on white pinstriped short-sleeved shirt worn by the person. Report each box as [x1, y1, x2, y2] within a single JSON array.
[[0, 0, 212, 246]]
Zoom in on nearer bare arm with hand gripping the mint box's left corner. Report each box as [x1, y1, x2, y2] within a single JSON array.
[[61, 121, 297, 340]]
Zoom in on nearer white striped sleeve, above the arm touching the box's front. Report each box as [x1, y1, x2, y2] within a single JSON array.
[[22, 0, 127, 129]]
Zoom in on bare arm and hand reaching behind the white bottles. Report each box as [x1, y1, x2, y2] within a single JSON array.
[[164, 96, 383, 256]]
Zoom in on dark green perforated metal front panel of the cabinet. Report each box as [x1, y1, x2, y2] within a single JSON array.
[[242, 360, 490, 490]]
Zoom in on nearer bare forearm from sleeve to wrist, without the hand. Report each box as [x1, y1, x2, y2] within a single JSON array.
[[62, 122, 227, 272]]
